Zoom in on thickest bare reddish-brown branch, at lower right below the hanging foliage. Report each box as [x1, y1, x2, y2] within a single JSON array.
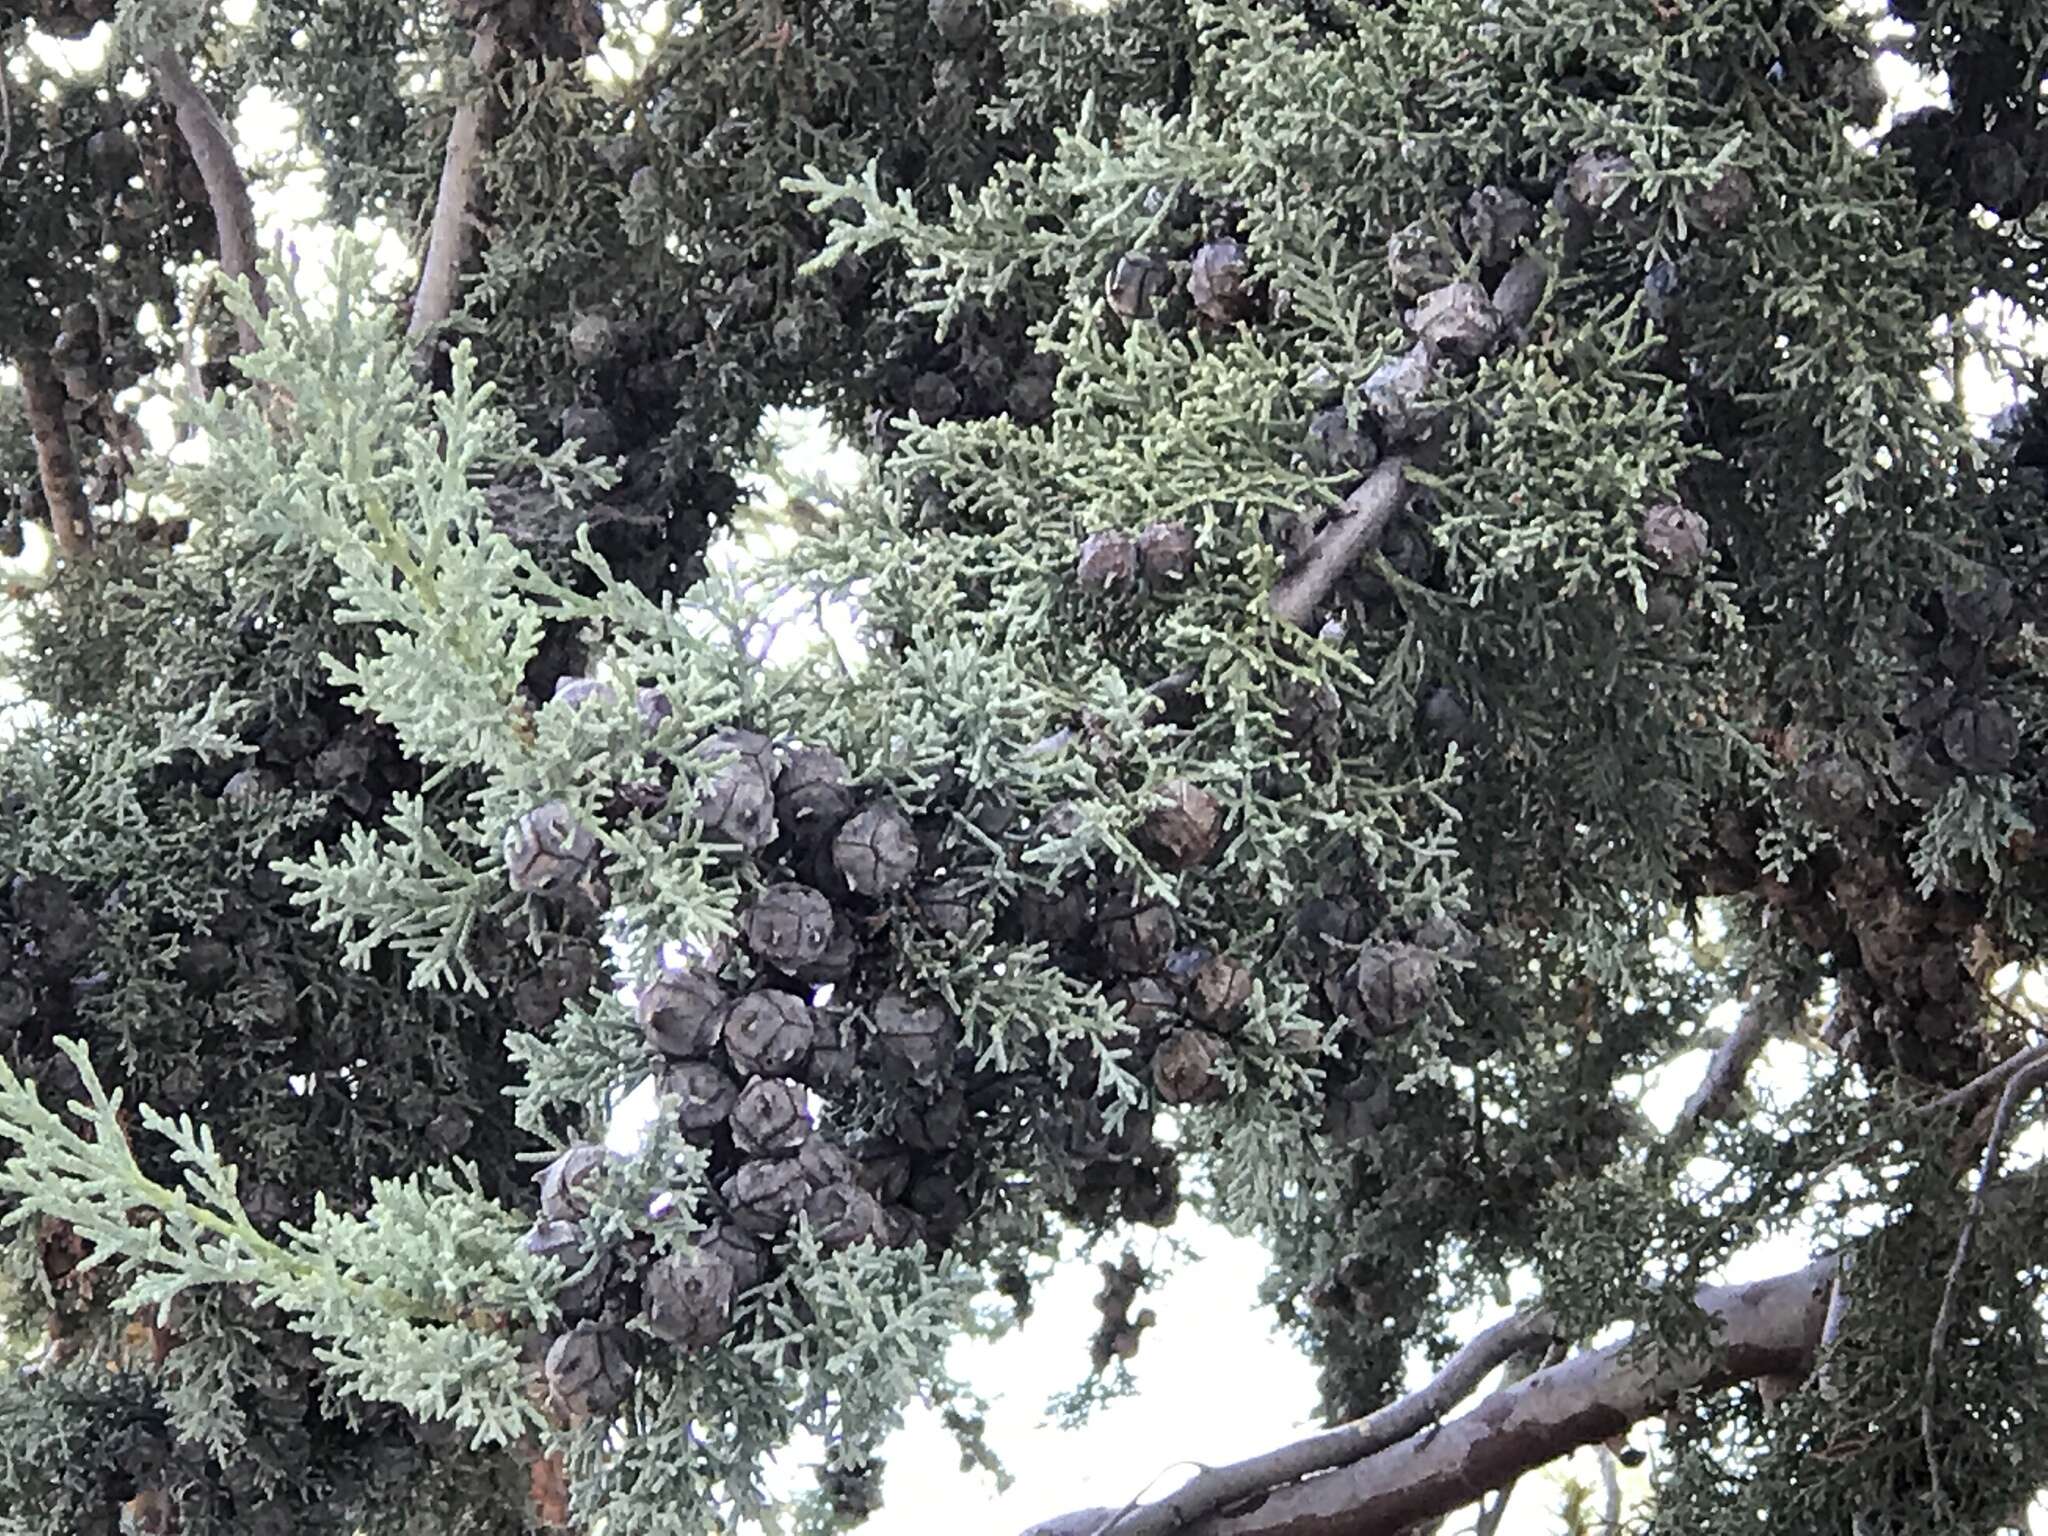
[[1190, 1257, 1837, 1536]]
